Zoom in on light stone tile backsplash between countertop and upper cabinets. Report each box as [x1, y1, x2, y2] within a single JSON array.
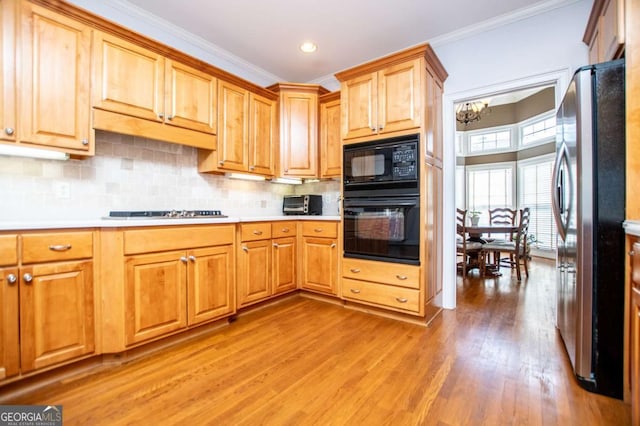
[[0, 131, 340, 221]]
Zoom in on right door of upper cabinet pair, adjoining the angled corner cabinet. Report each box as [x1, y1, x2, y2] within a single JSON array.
[[249, 93, 277, 176]]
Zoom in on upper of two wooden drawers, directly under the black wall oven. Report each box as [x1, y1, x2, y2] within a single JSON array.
[[342, 258, 420, 289]]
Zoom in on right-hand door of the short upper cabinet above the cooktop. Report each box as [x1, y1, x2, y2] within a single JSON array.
[[164, 59, 218, 134]]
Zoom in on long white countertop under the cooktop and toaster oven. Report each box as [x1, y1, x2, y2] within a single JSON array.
[[0, 216, 340, 231]]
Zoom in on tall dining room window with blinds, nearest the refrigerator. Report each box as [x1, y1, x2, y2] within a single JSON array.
[[518, 155, 556, 250]]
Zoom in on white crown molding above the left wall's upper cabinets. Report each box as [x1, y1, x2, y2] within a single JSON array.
[[97, 0, 283, 86]]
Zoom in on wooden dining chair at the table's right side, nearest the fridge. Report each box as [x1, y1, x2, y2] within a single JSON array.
[[480, 207, 531, 281]]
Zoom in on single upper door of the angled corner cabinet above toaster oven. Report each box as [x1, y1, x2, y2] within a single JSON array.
[[280, 91, 318, 177]]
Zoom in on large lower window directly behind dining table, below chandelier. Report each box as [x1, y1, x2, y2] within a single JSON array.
[[467, 162, 515, 224]]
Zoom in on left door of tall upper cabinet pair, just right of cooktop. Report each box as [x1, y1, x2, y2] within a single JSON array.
[[218, 80, 249, 171]]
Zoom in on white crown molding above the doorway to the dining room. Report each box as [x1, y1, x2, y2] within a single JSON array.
[[427, 0, 582, 47]]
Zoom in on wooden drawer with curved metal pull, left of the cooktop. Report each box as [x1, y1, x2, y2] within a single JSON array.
[[22, 231, 93, 263]]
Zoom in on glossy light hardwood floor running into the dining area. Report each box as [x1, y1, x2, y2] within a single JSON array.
[[1, 261, 631, 425]]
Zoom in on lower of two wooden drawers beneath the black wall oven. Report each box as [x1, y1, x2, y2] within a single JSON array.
[[342, 278, 420, 312]]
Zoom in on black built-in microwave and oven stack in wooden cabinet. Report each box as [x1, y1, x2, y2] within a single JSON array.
[[343, 134, 420, 265]]
